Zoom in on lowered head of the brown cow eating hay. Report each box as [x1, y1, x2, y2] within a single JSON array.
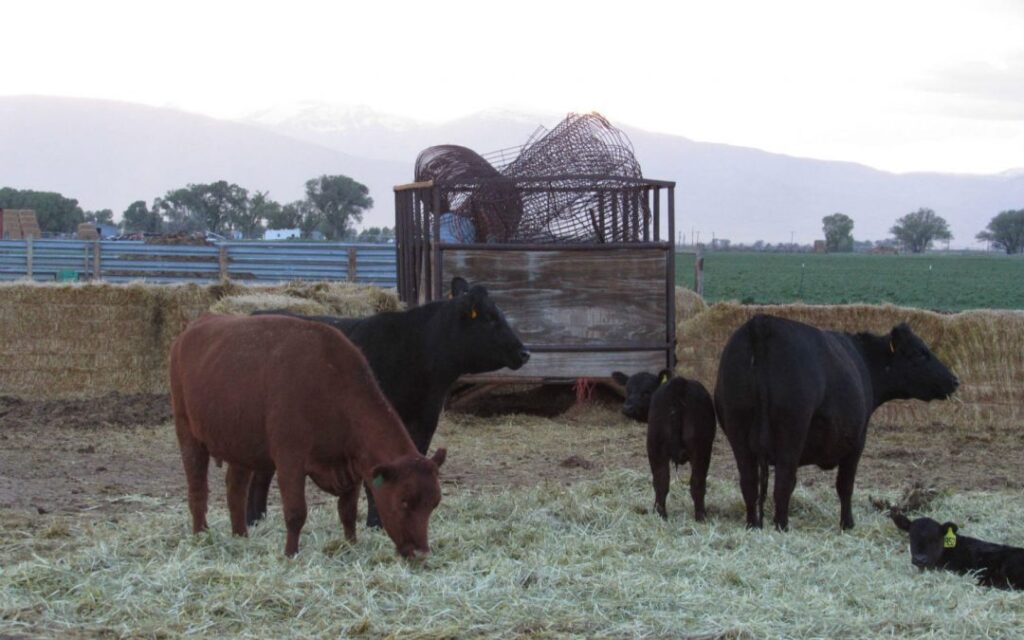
[[370, 449, 447, 558]]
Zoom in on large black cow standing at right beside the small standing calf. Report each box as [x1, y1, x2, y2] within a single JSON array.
[[715, 314, 958, 529]]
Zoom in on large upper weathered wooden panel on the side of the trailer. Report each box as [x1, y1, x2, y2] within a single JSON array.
[[443, 247, 669, 344]]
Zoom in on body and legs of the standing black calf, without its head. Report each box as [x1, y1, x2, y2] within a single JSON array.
[[647, 378, 715, 520]]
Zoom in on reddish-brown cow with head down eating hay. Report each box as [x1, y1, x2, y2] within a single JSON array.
[[171, 315, 445, 557]]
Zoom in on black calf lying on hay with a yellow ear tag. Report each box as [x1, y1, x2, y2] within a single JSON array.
[[890, 510, 1024, 589]]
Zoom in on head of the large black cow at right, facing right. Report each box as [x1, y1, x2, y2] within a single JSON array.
[[885, 323, 959, 400]]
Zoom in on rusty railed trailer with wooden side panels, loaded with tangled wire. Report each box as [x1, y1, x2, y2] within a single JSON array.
[[394, 114, 675, 382]]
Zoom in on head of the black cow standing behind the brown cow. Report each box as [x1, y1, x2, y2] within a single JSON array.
[[450, 278, 529, 374]]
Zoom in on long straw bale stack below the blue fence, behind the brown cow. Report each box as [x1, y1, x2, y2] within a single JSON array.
[[0, 282, 399, 398]]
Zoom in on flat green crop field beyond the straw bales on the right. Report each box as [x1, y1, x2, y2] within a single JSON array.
[[676, 252, 1024, 311]]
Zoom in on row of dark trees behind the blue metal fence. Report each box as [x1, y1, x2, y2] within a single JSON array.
[[0, 175, 394, 242]]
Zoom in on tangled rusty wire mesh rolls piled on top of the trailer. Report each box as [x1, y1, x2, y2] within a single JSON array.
[[416, 114, 649, 243]]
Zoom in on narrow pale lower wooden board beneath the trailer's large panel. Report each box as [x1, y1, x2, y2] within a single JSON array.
[[460, 351, 665, 383]]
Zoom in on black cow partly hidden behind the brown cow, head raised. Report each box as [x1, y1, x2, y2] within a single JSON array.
[[247, 278, 529, 526]]
